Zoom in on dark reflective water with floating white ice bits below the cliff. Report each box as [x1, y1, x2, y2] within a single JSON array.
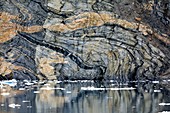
[[0, 80, 170, 113]]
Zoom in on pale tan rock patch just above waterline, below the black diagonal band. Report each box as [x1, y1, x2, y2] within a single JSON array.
[[36, 46, 67, 79]]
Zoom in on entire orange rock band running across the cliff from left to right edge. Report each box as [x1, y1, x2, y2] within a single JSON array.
[[0, 12, 170, 44]]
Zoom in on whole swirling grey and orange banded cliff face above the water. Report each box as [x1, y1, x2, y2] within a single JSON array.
[[0, 0, 170, 81]]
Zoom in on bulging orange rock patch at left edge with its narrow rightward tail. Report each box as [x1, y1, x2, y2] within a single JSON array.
[[0, 12, 42, 43]]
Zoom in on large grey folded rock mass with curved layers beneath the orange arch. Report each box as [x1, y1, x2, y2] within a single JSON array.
[[42, 25, 169, 80]]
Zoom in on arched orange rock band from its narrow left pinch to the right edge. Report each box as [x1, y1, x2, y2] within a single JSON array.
[[43, 12, 170, 44]]
